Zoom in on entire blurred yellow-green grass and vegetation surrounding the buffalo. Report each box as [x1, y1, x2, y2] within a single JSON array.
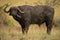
[[0, 0, 60, 40]]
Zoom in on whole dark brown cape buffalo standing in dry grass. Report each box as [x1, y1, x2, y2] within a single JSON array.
[[4, 5, 54, 34]]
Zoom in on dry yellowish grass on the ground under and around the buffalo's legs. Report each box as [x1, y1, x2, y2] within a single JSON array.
[[0, 25, 60, 40]]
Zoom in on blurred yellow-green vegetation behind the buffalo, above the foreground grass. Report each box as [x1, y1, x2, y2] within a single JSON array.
[[0, 0, 60, 26]]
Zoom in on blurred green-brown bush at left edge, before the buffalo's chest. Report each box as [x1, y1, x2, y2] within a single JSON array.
[[0, 6, 14, 26]]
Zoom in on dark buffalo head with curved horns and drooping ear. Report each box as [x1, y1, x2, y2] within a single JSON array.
[[4, 5, 24, 18]]
